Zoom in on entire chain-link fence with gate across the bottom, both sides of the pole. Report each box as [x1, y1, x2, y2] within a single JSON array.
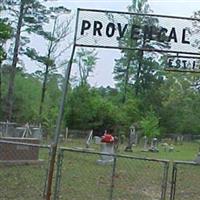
[[0, 138, 200, 200]]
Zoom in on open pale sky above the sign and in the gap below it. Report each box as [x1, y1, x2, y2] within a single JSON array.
[[29, 0, 200, 87]]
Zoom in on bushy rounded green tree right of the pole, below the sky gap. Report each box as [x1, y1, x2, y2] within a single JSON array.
[[65, 84, 119, 130]]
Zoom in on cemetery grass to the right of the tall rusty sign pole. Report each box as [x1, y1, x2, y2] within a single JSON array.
[[55, 139, 200, 200]]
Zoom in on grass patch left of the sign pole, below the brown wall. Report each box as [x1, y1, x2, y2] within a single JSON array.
[[0, 149, 48, 200]]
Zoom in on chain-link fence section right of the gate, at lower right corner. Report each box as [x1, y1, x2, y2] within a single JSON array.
[[170, 161, 200, 200]]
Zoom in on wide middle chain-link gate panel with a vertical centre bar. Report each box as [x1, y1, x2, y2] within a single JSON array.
[[54, 148, 169, 200]]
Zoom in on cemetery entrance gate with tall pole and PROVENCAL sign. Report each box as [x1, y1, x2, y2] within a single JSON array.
[[46, 9, 200, 200]]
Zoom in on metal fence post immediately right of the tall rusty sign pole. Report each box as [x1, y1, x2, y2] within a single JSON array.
[[53, 149, 64, 200]]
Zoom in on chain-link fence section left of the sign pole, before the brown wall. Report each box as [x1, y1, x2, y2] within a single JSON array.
[[0, 139, 50, 200]]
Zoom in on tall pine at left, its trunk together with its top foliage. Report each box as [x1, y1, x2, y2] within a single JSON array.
[[4, 0, 50, 120]]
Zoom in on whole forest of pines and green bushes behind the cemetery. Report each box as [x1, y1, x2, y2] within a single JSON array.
[[0, 0, 200, 137]]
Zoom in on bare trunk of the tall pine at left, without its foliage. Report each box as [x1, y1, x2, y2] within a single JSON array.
[[6, 1, 24, 121]]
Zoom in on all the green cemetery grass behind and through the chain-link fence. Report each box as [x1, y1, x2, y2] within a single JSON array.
[[0, 139, 200, 200]]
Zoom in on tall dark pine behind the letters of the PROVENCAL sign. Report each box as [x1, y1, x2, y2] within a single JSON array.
[[114, 0, 168, 103]]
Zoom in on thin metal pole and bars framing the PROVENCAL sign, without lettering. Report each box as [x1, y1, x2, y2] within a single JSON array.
[[46, 8, 200, 200]]
